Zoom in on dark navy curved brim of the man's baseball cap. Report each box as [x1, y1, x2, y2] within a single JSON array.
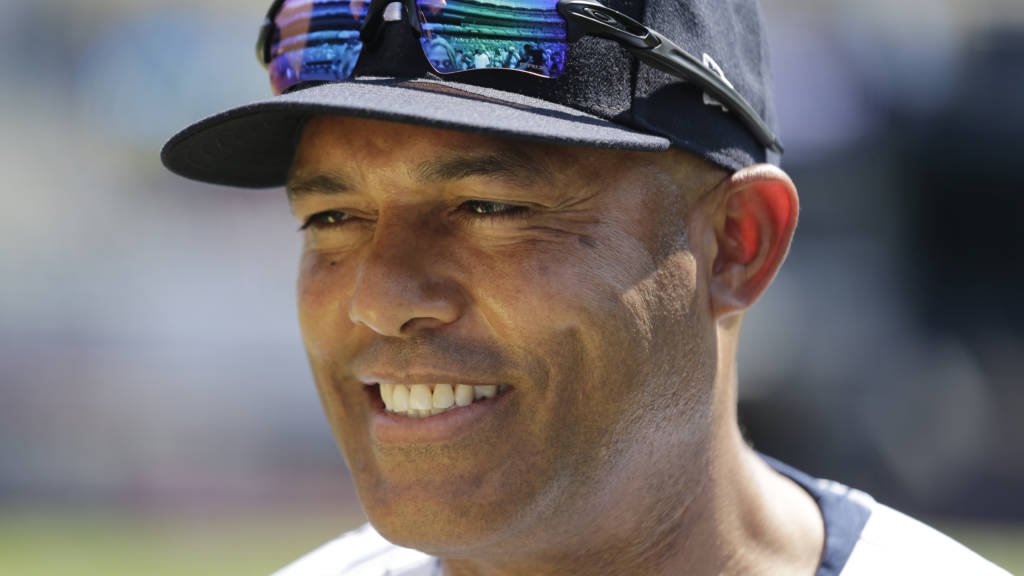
[[161, 78, 670, 188]]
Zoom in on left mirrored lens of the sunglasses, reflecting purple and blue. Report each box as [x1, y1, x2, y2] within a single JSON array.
[[267, 0, 369, 94]]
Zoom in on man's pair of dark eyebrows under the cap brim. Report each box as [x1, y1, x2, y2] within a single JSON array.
[[286, 147, 552, 201]]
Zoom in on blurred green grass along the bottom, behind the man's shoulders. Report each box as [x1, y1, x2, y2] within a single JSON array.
[[0, 509, 1024, 576]]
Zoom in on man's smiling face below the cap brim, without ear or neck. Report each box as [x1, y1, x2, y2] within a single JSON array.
[[289, 118, 721, 556]]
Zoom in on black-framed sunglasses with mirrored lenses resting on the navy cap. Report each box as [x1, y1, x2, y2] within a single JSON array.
[[256, 0, 782, 154]]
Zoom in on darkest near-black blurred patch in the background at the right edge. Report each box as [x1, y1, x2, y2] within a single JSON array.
[[906, 30, 1024, 334]]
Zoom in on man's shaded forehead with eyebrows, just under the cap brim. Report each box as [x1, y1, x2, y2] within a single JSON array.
[[289, 116, 725, 206]]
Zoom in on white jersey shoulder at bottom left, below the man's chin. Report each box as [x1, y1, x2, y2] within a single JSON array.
[[272, 524, 436, 576]]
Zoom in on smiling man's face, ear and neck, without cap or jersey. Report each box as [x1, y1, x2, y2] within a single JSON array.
[[289, 117, 822, 574]]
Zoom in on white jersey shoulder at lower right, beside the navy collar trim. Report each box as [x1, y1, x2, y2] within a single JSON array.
[[841, 500, 1010, 576]]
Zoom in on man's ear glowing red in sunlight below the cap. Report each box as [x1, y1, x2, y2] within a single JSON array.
[[709, 164, 800, 319]]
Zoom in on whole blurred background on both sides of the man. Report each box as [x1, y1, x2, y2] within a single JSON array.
[[0, 0, 1024, 575]]
